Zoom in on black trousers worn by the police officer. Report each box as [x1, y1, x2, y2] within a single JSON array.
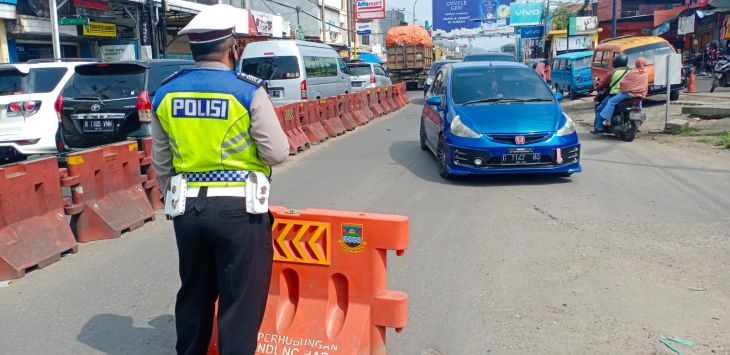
[[173, 196, 273, 355]]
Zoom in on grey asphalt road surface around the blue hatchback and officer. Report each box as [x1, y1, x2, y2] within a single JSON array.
[[0, 93, 730, 354]]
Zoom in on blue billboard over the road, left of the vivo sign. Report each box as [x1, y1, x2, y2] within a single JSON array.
[[431, 0, 510, 32]]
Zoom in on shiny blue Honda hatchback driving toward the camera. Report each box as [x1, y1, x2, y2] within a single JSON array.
[[420, 62, 581, 179]]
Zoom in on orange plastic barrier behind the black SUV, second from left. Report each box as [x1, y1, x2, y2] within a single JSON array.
[[67, 141, 155, 243]]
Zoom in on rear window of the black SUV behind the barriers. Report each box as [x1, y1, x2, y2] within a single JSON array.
[[63, 63, 147, 100]]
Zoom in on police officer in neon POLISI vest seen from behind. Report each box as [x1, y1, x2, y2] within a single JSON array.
[[152, 5, 289, 355]]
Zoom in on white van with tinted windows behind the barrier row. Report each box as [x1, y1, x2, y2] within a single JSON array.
[[241, 40, 352, 105]]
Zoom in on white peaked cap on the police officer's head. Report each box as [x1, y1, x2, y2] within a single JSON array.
[[178, 4, 248, 44]]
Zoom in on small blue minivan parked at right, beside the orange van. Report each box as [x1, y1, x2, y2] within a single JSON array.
[[550, 51, 593, 100]]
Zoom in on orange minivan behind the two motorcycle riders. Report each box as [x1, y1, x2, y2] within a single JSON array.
[[591, 36, 685, 101]]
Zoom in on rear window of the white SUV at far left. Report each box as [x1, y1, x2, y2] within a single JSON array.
[[0, 67, 68, 95]]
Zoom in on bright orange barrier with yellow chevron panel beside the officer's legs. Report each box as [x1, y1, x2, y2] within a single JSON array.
[[208, 207, 408, 355]]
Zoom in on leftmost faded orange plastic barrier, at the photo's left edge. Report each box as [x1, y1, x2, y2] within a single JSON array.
[[0, 157, 78, 280]]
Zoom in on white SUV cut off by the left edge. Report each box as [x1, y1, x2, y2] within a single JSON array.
[[0, 59, 94, 164]]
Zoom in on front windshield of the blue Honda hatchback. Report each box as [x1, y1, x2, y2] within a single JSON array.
[[451, 67, 553, 105]]
